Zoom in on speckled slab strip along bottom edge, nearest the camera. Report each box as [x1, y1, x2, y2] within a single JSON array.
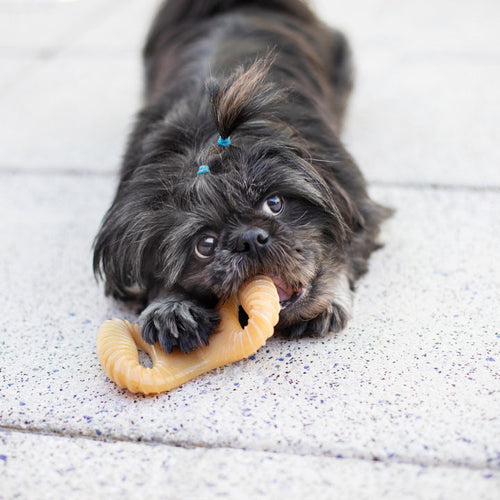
[[0, 431, 500, 500]]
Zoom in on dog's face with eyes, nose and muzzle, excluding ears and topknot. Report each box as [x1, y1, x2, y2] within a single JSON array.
[[148, 136, 350, 327]]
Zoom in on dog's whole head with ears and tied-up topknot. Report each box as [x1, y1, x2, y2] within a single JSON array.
[[94, 56, 368, 325]]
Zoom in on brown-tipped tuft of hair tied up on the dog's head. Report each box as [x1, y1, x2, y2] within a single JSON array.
[[207, 52, 283, 139]]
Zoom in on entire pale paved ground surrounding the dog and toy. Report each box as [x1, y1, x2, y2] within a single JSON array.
[[0, 0, 500, 499]]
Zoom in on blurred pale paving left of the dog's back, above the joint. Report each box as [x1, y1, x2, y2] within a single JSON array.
[[0, 0, 158, 172]]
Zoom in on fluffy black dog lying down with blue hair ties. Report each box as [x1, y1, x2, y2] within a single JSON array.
[[94, 0, 388, 352]]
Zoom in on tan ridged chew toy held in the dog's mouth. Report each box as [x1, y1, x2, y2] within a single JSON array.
[[97, 276, 280, 394]]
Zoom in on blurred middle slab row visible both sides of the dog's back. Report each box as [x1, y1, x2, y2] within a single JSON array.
[[0, 54, 500, 186]]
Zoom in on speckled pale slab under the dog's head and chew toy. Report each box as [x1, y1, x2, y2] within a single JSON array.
[[0, 174, 500, 469]]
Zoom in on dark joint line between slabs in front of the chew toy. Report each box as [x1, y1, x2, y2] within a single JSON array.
[[0, 425, 499, 473]]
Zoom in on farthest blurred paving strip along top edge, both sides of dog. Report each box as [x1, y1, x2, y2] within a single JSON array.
[[0, 0, 500, 55]]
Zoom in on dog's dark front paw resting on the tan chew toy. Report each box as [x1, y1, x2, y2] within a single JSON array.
[[140, 297, 220, 353]]
